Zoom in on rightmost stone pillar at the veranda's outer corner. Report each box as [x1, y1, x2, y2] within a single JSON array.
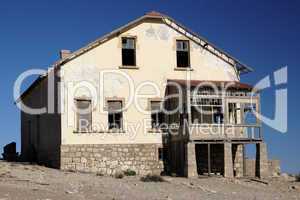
[[255, 142, 269, 178]]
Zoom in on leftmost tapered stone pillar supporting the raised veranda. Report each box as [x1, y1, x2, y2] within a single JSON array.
[[186, 142, 198, 178]]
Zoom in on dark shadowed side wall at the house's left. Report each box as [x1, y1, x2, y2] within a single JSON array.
[[21, 75, 61, 168]]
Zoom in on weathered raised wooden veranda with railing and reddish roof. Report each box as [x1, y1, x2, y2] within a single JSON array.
[[166, 80, 263, 142]]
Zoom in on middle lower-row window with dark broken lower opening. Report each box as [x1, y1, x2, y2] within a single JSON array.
[[107, 101, 123, 129]]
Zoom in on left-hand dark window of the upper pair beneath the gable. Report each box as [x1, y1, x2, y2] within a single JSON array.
[[122, 37, 136, 66]]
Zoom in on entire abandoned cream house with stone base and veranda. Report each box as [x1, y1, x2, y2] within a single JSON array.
[[16, 12, 278, 177]]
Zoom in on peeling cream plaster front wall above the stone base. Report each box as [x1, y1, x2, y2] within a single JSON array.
[[61, 22, 239, 144]]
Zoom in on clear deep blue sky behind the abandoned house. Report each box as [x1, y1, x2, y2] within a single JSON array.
[[0, 0, 300, 173]]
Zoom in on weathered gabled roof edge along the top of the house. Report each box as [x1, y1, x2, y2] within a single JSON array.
[[19, 11, 253, 99]]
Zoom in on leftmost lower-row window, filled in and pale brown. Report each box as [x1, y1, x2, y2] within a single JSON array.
[[75, 99, 92, 132]]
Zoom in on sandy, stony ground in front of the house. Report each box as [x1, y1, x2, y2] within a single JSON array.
[[0, 162, 300, 200]]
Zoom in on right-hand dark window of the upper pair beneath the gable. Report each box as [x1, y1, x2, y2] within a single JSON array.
[[176, 40, 190, 67]]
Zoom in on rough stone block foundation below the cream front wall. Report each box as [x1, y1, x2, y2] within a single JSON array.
[[60, 144, 163, 175]]
